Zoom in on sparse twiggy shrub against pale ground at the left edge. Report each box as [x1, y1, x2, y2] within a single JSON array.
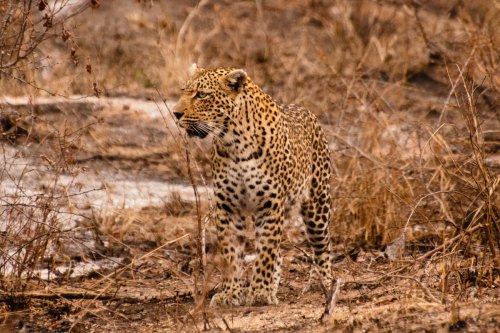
[[0, 118, 91, 292]]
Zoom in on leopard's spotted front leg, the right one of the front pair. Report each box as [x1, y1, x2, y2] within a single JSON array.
[[247, 198, 284, 305]]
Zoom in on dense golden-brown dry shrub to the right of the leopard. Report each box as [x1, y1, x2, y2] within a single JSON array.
[[332, 72, 499, 250]]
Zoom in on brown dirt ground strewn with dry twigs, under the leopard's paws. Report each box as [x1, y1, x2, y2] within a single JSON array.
[[8, 250, 500, 332]]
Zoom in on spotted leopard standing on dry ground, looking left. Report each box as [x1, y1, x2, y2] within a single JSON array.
[[173, 64, 333, 307]]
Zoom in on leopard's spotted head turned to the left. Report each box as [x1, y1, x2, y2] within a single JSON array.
[[174, 64, 249, 138]]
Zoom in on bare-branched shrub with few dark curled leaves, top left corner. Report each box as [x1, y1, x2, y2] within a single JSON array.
[[0, 0, 90, 96]]
